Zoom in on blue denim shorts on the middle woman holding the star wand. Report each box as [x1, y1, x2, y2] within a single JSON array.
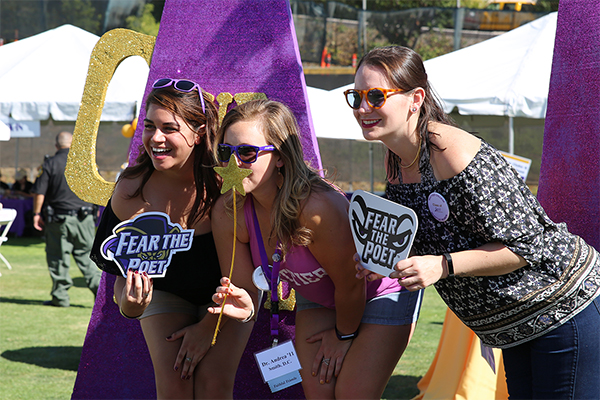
[[296, 288, 423, 325]]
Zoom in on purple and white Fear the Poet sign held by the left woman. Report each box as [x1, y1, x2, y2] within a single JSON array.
[[101, 212, 194, 278]]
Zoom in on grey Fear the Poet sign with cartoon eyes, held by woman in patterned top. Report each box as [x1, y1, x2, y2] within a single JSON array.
[[348, 190, 418, 276]]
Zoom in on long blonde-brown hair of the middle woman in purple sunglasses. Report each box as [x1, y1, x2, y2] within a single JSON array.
[[214, 99, 334, 256]]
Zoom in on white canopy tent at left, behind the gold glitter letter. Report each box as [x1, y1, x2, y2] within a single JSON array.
[[0, 25, 149, 121]]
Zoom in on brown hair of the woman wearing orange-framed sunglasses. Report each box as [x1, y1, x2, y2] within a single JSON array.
[[356, 46, 456, 180]]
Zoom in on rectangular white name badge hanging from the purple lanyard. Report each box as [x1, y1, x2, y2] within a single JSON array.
[[254, 340, 302, 391]]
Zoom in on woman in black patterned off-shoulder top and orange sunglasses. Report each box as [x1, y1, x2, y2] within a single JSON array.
[[345, 46, 600, 399]]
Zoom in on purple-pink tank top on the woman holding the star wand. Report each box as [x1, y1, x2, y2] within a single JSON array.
[[244, 194, 402, 308]]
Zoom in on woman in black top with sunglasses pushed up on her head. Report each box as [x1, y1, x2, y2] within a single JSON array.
[[92, 78, 252, 399]]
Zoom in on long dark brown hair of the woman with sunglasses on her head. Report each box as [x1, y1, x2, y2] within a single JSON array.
[[119, 86, 219, 227]]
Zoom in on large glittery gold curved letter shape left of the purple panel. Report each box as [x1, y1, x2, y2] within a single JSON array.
[[65, 29, 156, 205]]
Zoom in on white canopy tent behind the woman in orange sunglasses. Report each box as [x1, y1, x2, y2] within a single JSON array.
[[324, 12, 558, 152]]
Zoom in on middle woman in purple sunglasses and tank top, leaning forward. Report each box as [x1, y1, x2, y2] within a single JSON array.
[[209, 100, 421, 399]]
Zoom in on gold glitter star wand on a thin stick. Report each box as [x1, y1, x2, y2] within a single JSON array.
[[210, 154, 252, 347]]
